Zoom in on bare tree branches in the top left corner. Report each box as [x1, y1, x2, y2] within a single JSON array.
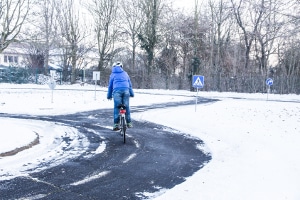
[[0, 0, 29, 53]]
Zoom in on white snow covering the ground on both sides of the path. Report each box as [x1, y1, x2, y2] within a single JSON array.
[[0, 84, 300, 200]]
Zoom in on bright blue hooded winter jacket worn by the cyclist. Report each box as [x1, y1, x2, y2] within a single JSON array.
[[107, 66, 134, 99]]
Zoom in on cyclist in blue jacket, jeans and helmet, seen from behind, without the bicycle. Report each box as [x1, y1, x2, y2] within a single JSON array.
[[107, 62, 134, 131]]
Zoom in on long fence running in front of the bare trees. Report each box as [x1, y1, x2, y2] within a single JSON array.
[[0, 67, 300, 94]]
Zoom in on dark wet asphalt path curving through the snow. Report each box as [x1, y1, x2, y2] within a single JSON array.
[[0, 98, 215, 200]]
